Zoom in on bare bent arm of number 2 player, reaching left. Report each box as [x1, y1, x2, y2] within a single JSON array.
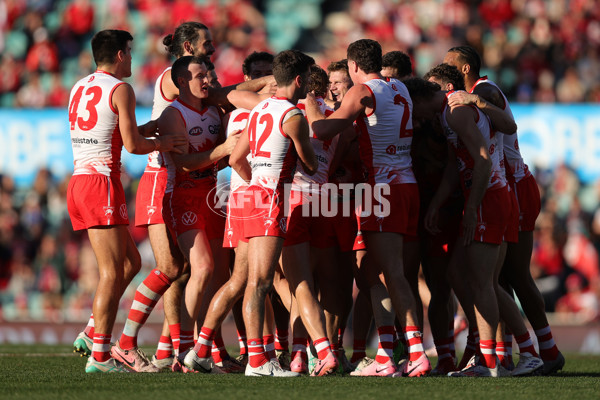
[[306, 85, 374, 140]]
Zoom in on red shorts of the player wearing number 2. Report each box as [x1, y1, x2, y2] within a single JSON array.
[[357, 183, 419, 236]]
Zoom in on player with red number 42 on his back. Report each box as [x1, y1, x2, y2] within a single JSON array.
[[230, 50, 328, 376]]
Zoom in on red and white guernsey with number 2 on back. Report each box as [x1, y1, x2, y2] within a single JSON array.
[[356, 79, 417, 185]]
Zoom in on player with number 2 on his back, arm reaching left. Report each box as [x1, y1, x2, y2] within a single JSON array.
[[307, 39, 431, 376]]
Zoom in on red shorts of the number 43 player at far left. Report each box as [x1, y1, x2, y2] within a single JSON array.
[[67, 175, 129, 231]]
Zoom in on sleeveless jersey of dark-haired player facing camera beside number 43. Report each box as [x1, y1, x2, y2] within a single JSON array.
[[164, 99, 221, 193]]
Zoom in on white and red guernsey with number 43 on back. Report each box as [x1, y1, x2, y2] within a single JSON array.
[[69, 71, 125, 176]]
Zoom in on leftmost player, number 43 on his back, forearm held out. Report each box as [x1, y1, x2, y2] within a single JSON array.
[[67, 30, 182, 372]]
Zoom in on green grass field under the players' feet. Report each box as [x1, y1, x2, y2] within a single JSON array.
[[0, 345, 600, 400]]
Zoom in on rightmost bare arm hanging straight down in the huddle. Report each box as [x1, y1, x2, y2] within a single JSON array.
[[446, 106, 492, 246]]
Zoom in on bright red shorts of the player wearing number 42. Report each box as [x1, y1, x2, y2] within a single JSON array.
[[243, 185, 287, 239]]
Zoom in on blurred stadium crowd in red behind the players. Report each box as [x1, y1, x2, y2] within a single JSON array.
[[0, 0, 600, 322]]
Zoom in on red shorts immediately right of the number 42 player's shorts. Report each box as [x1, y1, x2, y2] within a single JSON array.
[[283, 191, 335, 249]]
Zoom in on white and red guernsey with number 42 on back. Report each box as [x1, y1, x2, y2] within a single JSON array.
[[248, 96, 302, 190]]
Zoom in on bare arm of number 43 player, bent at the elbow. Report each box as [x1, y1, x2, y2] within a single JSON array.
[[112, 84, 187, 154]]
